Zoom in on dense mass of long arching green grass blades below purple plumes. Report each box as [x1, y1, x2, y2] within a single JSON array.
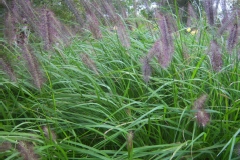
[[0, 0, 240, 160]]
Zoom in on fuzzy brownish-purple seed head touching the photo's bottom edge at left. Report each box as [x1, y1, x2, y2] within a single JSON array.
[[17, 141, 39, 160]]
